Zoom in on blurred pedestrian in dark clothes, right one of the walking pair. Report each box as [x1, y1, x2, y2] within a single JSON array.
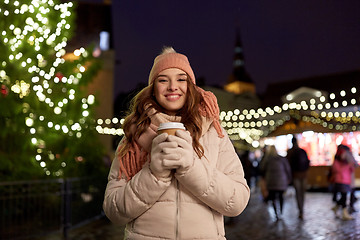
[[286, 136, 310, 219]]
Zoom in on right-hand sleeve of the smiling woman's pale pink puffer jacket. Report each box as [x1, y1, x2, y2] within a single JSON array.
[[175, 127, 250, 216]]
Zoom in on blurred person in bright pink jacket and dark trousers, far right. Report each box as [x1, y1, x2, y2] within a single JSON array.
[[330, 144, 355, 220]]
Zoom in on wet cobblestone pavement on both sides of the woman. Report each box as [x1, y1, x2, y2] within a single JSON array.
[[45, 188, 360, 240]]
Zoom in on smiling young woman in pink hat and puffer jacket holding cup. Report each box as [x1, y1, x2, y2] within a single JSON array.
[[104, 48, 250, 239]]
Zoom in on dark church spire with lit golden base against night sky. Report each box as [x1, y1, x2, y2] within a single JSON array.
[[224, 30, 256, 94]]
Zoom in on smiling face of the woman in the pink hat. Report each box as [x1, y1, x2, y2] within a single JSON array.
[[154, 68, 188, 115]]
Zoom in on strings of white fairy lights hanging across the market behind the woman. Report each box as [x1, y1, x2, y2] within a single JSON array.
[[96, 84, 360, 147]]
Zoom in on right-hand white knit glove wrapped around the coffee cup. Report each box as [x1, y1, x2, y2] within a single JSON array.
[[164, 130, 194, 174]]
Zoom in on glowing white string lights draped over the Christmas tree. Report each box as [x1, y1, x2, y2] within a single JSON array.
[[0, 0, 101, 176]]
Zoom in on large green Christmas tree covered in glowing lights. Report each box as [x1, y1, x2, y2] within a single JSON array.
[[0, 0, 104, 180]]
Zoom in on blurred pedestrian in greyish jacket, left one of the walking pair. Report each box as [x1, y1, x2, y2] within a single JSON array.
[[262, 145, 291, 220]]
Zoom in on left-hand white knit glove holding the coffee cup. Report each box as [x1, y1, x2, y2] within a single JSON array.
[[150, 133, 177, 179]]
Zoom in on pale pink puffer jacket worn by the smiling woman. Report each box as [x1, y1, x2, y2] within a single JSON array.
[[103, 125, 250, 240]]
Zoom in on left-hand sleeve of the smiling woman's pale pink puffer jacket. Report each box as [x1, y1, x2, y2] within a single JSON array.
[[103, 155, 171, 225]]
